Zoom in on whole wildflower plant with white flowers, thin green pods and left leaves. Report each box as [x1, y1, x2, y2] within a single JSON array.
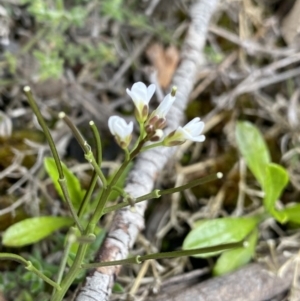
[[0, 82, 238, 301]]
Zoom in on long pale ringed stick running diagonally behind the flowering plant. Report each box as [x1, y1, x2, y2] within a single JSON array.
[[76, 0, 218, 301]]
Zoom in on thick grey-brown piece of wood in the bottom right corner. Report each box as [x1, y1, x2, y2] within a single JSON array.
[[147, 253, 295, 301]]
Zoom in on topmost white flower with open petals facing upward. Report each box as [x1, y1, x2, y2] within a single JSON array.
[[126, 82, 156, 122]]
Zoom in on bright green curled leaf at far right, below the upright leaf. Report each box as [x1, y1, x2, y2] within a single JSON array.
[[263, 163, 289, 223]]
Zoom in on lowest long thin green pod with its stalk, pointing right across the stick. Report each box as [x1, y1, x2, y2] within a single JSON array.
[[81, 241, 244, 269]]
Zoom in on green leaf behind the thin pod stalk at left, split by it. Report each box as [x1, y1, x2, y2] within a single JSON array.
[[44, 157, 85, 210]]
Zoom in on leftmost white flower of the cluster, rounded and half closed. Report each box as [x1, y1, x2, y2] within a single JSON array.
[[108, 116, 133, 148]]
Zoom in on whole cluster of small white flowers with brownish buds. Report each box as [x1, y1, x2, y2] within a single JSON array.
[[108, 82, 205, 149]]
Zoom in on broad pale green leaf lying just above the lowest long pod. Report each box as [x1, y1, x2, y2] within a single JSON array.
[[183, 217, 258, 258]]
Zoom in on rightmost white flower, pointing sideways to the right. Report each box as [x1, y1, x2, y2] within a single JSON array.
[[163, 117, 205, 146]]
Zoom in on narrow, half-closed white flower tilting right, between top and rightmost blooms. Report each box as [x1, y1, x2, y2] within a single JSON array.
[[146, 93, 176, 129]]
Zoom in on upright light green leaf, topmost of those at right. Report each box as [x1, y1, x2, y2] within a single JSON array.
[[235, 121, 271, 186]]
